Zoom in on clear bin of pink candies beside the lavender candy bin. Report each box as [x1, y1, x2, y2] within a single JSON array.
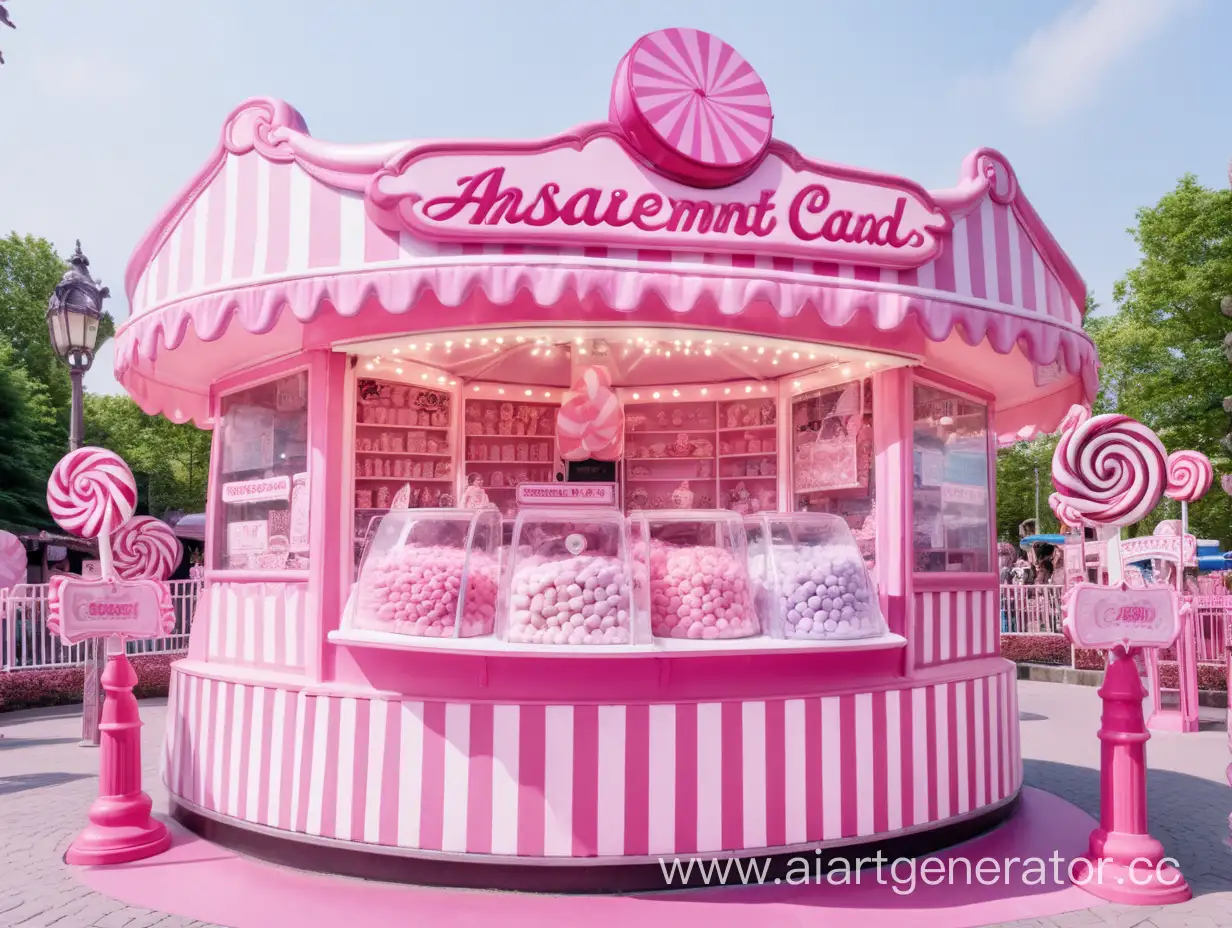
[[630, 509, 760, 638]]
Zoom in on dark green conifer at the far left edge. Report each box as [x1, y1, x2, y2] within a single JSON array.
[[0, 341, 59, 531]]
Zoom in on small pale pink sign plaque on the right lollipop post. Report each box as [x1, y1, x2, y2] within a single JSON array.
[[1064, 583, 1180, 648]]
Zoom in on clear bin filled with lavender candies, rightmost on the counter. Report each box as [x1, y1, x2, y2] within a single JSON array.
[[745, 513, 886, 641]]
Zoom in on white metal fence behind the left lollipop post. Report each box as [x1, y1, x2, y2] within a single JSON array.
[[0, 580, 201, 672]]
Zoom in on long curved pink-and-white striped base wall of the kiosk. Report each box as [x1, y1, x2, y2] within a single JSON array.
[[164, 667, 1023, 859]]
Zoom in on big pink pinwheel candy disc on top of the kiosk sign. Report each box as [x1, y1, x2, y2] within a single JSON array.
[[611, 28, 774, 187]]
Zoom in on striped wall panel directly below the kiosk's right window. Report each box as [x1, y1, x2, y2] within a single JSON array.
[[913, 589, 1000, 667]]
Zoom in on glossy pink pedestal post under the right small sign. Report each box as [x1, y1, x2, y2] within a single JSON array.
[[1072, 647, 1191, 906]]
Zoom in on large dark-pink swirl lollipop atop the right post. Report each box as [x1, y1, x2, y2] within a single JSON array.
[[1050, 410, 1167, 526]]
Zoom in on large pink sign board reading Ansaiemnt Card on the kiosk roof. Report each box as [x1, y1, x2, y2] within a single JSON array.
[[367, 128, 952, 267]]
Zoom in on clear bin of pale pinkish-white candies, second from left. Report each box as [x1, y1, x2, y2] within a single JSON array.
[[499, 509, 649, 647]]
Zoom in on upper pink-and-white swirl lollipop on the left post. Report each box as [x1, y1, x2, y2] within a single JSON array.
[[47, 447, 137, 539]]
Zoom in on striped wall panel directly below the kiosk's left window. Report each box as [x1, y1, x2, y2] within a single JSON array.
[[202, 580, 308, 672]]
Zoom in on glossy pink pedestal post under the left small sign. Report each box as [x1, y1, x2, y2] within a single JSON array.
[[64, 648, 171, 865]]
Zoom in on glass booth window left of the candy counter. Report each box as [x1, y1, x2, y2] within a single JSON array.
[[213, 371, 309, 571]]
